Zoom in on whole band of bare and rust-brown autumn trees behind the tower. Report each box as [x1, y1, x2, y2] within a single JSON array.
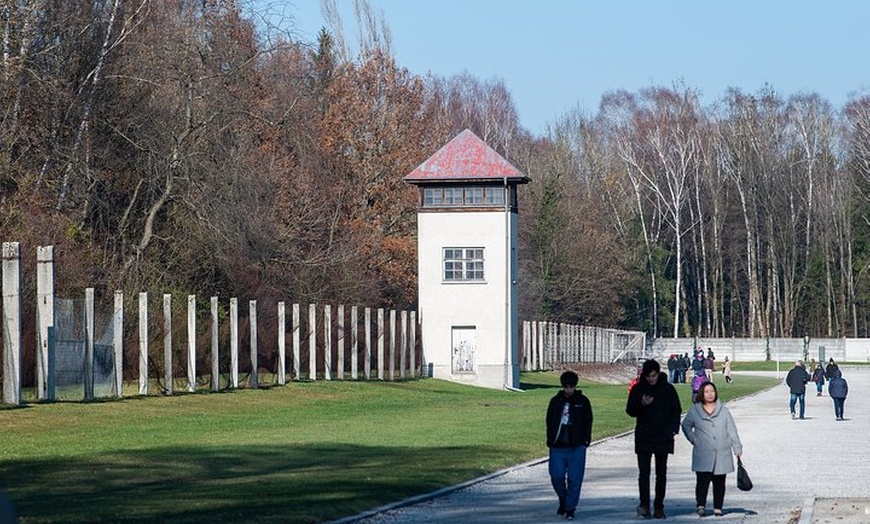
[[0, 0, 870, 342]]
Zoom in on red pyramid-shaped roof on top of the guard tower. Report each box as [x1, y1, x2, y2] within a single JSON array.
[[405, 129, 527, 184]]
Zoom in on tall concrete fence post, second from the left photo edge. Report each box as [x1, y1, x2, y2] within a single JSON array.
[[36, 246, 54, 400]]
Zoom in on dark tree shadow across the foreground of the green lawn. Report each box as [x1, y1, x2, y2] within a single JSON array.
[[0, 444, 504, 524]]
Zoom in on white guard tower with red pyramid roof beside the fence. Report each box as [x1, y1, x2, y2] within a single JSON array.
[[405, 129, 528, 389]]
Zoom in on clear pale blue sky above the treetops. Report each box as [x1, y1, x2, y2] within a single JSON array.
[[267, 0, 870, 134]]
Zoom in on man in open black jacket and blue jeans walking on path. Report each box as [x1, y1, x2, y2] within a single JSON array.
[[546, 371, 592, 520]]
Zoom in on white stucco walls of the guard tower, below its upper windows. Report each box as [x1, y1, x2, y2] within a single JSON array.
[[417, 210, 519, 388]]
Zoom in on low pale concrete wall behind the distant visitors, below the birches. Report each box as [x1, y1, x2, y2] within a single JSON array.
[[650, 338, 870, 362]]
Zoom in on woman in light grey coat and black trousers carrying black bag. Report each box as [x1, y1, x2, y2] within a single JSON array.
[[681, 382, 743, 517]]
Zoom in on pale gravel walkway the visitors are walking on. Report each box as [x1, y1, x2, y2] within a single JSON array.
[[342, 368, 870, 524]]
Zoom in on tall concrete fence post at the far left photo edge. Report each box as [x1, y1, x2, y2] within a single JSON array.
[[3, 242, 21, 404]]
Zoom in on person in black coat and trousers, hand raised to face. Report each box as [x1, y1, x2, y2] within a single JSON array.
[[625, 359, 683, 519]]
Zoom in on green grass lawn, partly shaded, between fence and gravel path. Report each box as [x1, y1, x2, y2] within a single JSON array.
[[0, 373, 776, 524]]
